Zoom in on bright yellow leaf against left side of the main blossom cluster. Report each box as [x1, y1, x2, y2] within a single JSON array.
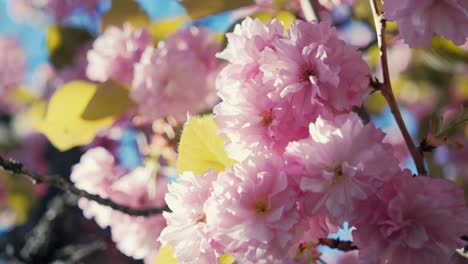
[[177, 115, 235, 175]]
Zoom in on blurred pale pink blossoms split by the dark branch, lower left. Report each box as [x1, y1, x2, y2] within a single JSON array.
[[70, 147, 167, 259]]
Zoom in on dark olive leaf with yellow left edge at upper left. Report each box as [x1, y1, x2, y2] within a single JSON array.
[[47, 25, 93, 69]]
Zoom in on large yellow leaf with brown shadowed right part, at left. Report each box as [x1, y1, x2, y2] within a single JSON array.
[[36, 81, 132, 151]]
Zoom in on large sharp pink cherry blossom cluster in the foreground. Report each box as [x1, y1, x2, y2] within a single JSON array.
[[159, 18, 468, 264]]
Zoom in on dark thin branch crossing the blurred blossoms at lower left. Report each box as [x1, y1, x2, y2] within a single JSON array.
[[0, 156, 169, 216]]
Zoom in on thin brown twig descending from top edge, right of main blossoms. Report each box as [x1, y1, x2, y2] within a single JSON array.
[[369, 0, 427, 175]]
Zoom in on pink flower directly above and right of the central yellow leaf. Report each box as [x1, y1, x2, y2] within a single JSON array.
[[213, 79, 318, 161]]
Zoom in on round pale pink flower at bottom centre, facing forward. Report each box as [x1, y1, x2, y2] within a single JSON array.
[[205, 157, 306, 263]]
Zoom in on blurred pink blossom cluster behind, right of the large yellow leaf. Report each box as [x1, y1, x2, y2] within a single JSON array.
[[87, 24, 220, 121]]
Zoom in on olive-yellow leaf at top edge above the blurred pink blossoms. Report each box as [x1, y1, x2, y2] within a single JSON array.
[[101, 0, 151, 31]]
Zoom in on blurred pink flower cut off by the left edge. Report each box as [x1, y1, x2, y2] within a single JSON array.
[[0, 37, 26, 104]]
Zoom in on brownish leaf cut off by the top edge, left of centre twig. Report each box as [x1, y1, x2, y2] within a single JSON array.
[[181, 0, 255, 19]]
